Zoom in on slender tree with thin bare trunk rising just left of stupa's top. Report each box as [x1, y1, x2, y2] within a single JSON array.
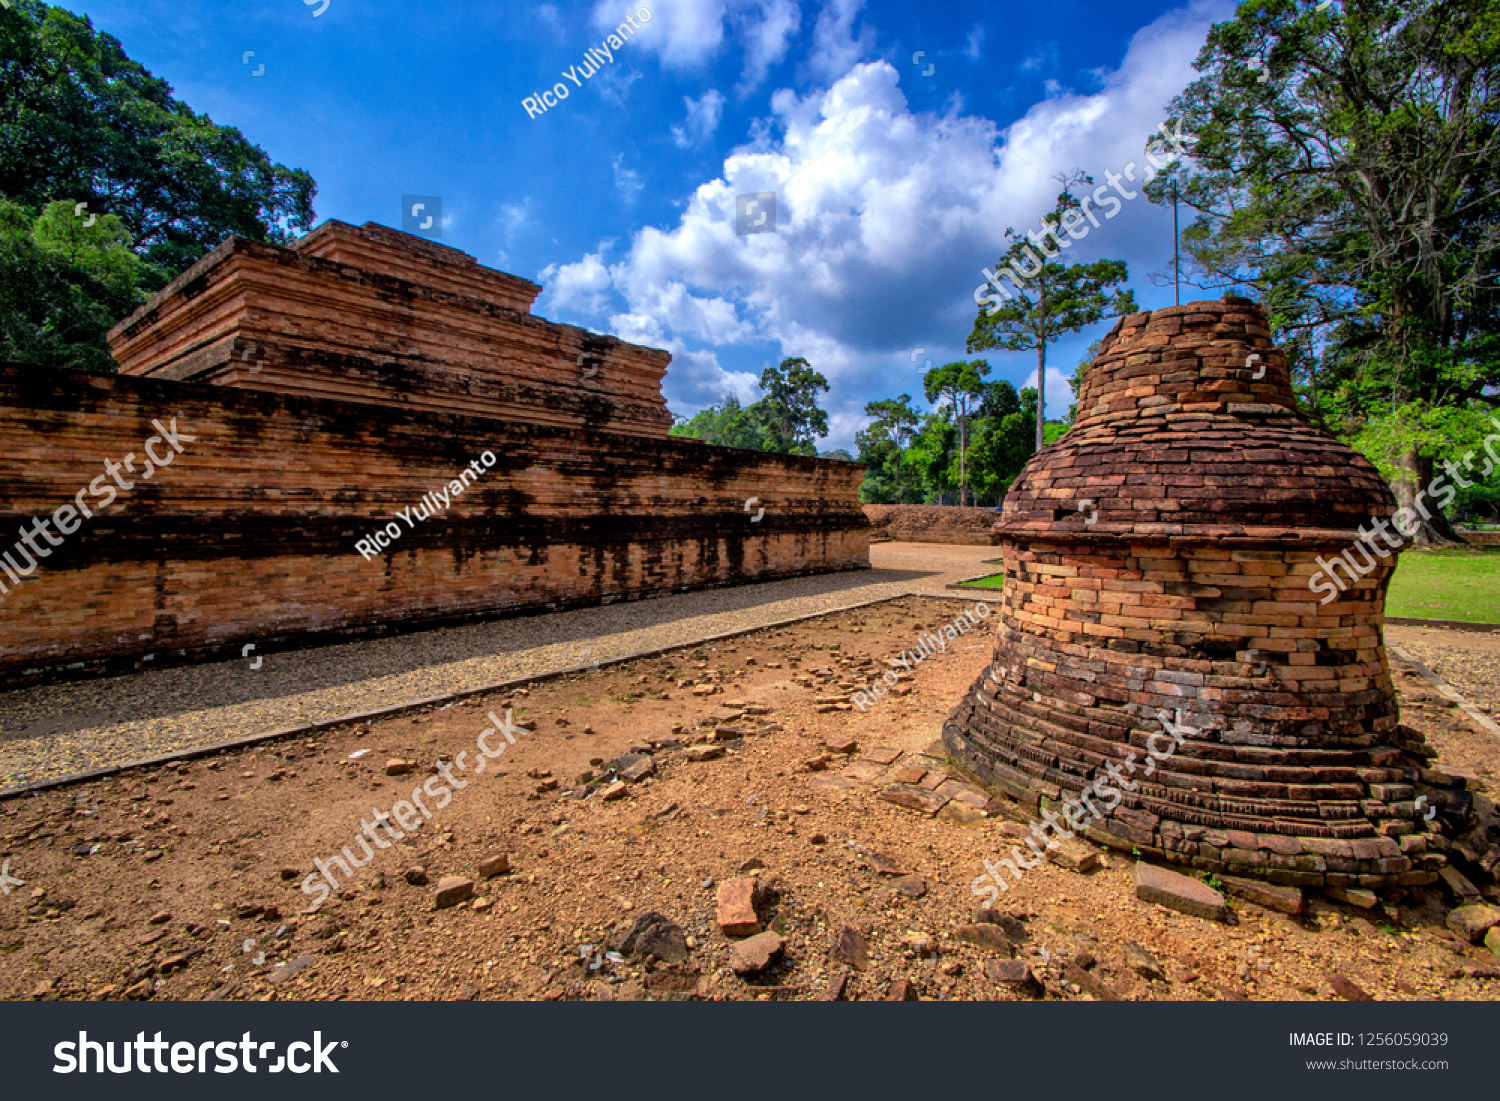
[[968, 173, 1136, 450]]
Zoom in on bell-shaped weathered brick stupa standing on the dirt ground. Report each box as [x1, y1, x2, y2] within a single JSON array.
[[944, 299, 1442, 887]]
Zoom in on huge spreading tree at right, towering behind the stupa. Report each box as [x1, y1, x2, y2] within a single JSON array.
[[1148, 0, 1500, 543]]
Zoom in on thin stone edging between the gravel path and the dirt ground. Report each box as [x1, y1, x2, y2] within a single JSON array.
[[0, 593, 990, 801]]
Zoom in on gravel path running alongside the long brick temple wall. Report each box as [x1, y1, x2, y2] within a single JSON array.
[[0, 543, 999, 789]]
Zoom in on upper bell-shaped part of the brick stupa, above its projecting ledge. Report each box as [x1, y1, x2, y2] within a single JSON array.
[[999, 302, 1394, 546]]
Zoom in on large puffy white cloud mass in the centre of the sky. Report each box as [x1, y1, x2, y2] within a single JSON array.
[[540, 0, 1232, 449]]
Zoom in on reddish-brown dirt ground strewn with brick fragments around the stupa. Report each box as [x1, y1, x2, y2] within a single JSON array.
[[0, 597, 1500, 1001]]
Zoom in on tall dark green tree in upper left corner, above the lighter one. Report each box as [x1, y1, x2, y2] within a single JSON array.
[[0, 0, 317, 280]]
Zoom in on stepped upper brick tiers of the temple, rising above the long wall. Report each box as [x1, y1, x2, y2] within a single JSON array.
[[110, 222, 672, 438]]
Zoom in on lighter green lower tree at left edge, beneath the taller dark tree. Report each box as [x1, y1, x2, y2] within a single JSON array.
[[0, 200, 159, 374]]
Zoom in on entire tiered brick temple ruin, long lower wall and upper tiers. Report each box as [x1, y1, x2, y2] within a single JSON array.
[[0, 222, 869, 683]]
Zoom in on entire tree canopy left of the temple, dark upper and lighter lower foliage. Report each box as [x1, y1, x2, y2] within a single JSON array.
[[0, 0, 317, 371]]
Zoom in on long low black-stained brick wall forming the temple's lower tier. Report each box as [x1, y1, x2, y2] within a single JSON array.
[[0, 366, 869, 683]]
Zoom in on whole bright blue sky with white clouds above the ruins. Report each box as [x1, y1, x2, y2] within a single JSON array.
[[71, 0, 1233, 450]]
